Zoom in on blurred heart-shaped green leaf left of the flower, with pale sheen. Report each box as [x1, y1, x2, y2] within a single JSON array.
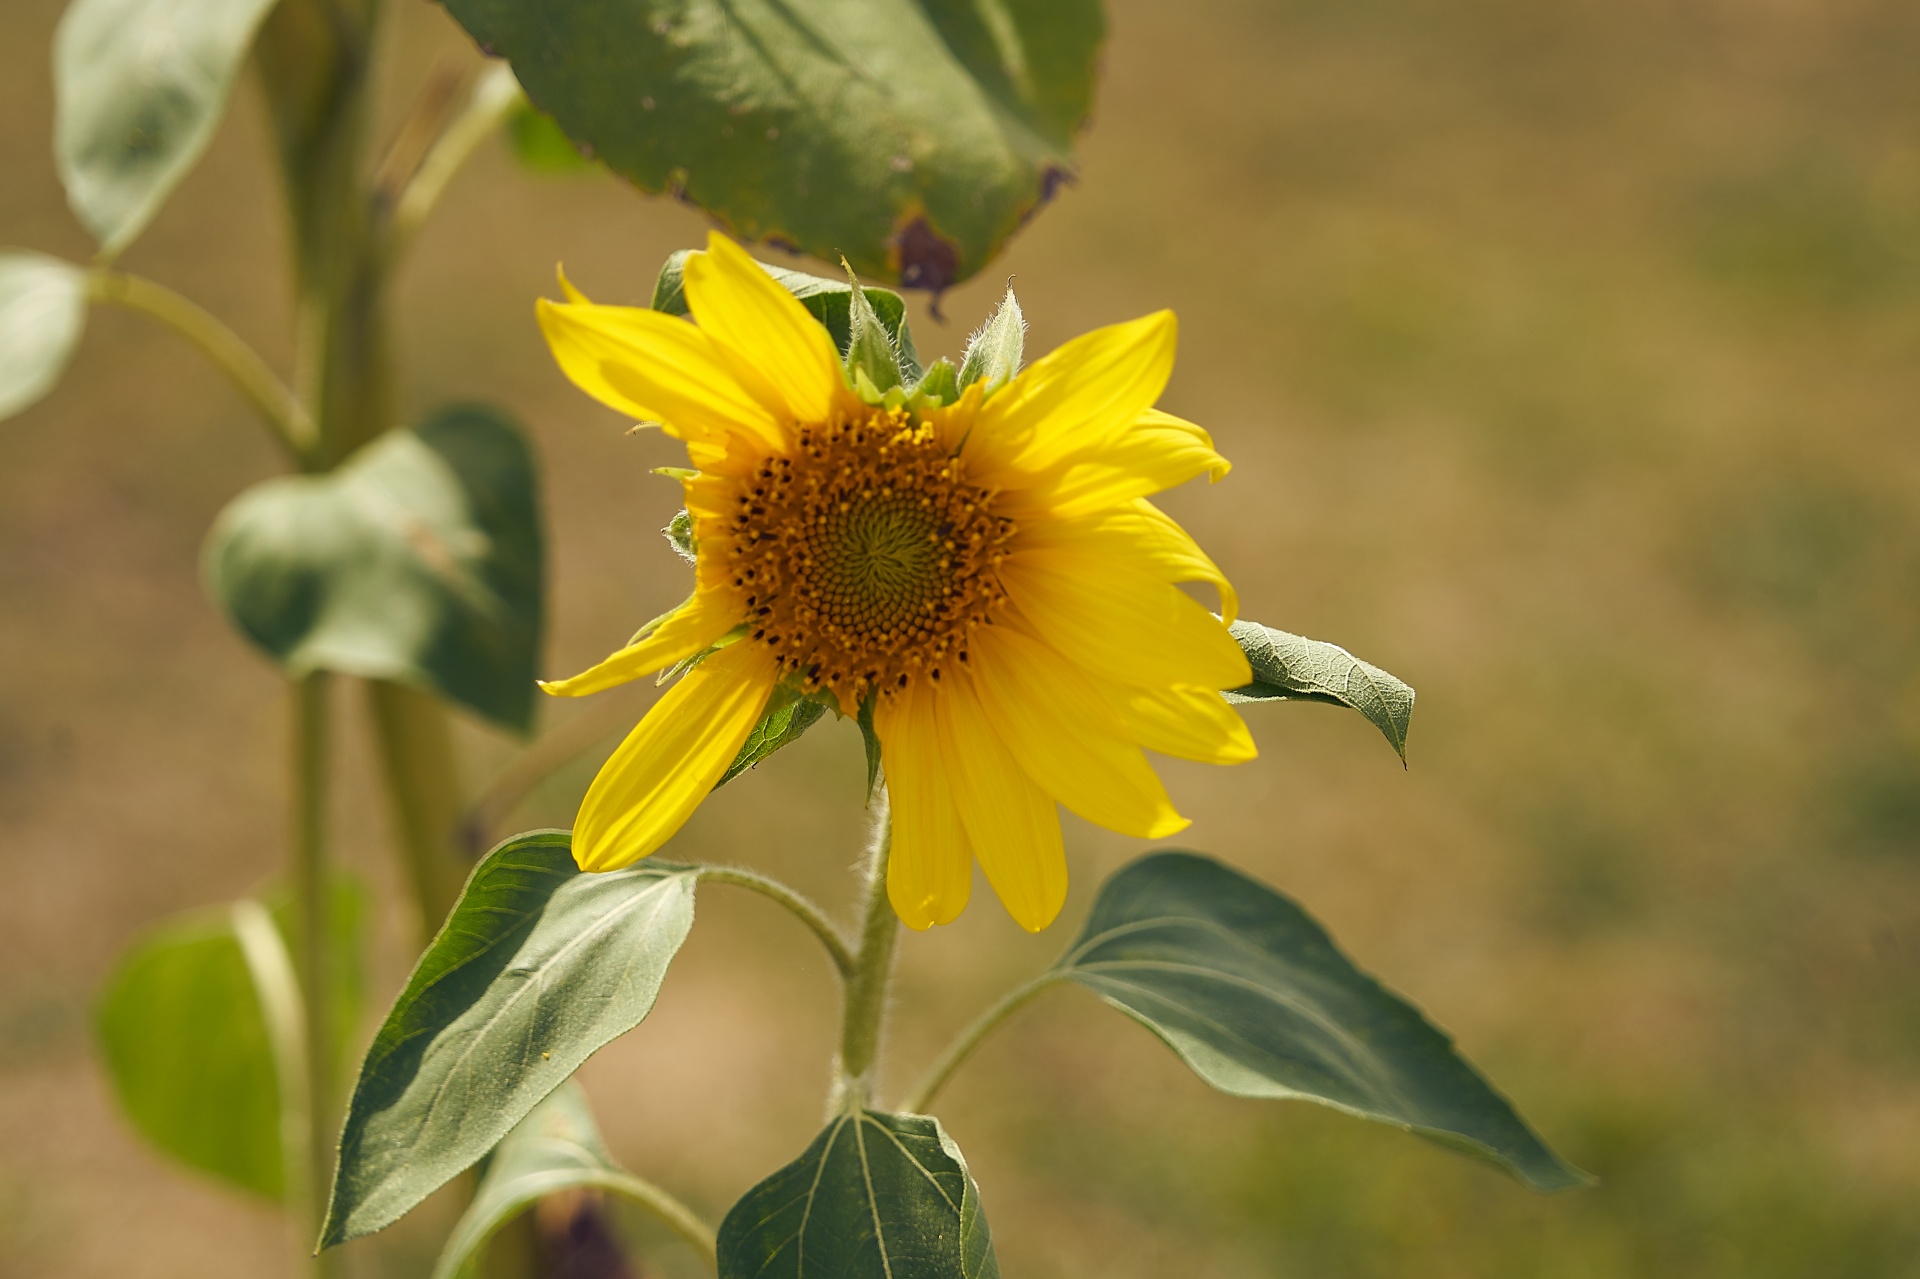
[[204, 405, 543, 732]]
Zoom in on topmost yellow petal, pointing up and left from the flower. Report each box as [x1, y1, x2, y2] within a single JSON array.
[[684, 230, 845, 422]]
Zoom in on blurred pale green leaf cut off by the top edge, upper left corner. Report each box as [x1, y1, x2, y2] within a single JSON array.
[[54, 0, 273, 255]]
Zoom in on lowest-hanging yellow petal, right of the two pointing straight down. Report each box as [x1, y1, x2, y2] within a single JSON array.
[[933, 672, 1068, 933]]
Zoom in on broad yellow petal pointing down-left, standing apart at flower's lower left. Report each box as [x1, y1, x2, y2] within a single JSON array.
[[574, 643, 778, 870]]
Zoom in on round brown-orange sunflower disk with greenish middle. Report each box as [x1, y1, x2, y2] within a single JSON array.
[[726, 409, 1014, 714]]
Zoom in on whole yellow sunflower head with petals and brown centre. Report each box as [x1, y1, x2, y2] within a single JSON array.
[[538, 234, 1254, 931]]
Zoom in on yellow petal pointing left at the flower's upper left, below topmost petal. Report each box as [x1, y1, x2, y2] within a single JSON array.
[[534, 298, 785, 451]]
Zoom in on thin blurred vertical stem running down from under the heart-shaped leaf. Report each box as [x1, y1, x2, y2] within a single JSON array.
[[292, 672, 334, 1275]]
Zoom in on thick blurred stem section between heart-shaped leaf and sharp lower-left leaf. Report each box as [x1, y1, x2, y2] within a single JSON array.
[[367, 680, 467, 945]]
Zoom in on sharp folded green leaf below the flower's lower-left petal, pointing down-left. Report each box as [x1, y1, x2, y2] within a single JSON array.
[[321, 832, 697, 1246]]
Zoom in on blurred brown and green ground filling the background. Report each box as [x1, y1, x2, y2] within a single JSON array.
[[0, 0, 1920, 1279]]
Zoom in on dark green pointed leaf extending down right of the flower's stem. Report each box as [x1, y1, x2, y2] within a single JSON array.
[[1058, 853, 1588, 1191]]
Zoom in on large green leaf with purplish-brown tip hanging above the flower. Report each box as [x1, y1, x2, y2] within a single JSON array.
[[445, 0, 1104, 292]]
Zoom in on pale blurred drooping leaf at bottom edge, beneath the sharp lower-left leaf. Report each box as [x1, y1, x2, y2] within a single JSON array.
[[432, 1081, 668, 1279]]
